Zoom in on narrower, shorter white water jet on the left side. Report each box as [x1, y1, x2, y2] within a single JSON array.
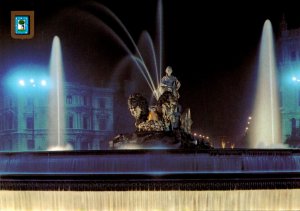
[[48, 36, 65, 150]]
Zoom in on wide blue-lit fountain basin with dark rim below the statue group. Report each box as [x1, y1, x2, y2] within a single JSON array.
[[0, 149, 300, 191]]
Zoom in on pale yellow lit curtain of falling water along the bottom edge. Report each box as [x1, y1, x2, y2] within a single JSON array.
[[0, 189, 300, 211]]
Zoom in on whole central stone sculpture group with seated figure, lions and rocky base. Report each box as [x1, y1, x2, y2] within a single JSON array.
[[109, 66, 212, 149]]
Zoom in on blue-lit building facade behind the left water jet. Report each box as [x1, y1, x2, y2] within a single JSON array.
[[0, 82, 114, 151]]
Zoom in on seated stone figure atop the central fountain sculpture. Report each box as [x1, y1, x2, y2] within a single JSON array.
[[160, 66, 181, 100]]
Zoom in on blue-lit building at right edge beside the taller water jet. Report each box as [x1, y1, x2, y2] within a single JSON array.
[[277, 18, 300, 147]]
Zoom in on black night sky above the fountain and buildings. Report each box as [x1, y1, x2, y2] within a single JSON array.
[[0, 0, 300, 143]]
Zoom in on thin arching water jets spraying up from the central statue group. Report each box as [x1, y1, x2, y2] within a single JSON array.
[[84, 0, 163, 100]]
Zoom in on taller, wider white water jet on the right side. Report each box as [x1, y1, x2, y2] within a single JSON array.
[[249, 20, 282, 148]]
